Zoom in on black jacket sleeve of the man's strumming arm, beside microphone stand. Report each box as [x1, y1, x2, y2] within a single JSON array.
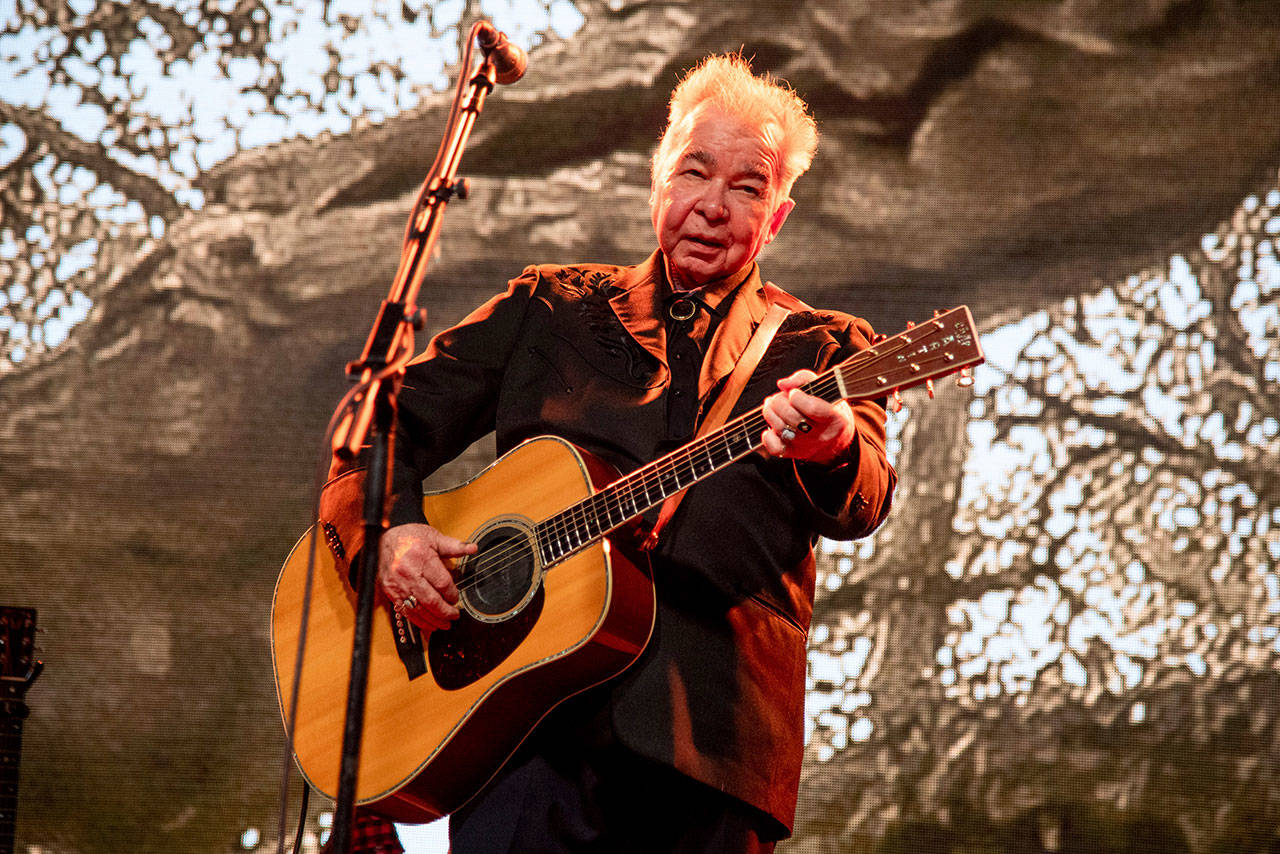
[[389, 266, 538, 525]]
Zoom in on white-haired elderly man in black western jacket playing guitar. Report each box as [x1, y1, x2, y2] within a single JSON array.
[[360, 56, 895, 854]]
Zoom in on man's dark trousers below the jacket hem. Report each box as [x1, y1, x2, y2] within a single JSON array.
[[449, 745, 778, 854]]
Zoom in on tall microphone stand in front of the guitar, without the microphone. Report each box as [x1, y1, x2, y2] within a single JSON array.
[[329, 22, 495, 854]]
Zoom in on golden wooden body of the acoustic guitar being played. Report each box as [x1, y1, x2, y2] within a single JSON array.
[[271, 437, 654, 822]]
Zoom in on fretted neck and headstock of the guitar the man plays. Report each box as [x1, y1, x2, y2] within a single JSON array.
[[536, 306, 983, 566]]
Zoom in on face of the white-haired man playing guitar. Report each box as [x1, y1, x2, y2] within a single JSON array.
[[650, 106, 795, 289]]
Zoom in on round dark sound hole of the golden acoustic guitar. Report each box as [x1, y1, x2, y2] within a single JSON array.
[[460, 525, 539, 620]]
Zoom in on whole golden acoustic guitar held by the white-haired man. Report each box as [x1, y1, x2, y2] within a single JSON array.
[[271, 306, 983, 822]]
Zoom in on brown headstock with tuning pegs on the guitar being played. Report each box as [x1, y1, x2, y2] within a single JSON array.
[[836, 306, 983, 399]]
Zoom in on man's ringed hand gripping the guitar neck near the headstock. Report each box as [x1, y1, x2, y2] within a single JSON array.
[[763, 370, 858, 463]]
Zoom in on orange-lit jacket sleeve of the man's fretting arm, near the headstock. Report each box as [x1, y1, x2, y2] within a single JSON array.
[[794, 318, 897, 540]]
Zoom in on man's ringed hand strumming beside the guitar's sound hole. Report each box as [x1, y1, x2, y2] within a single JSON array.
[[378, 524, 477, 630]]
